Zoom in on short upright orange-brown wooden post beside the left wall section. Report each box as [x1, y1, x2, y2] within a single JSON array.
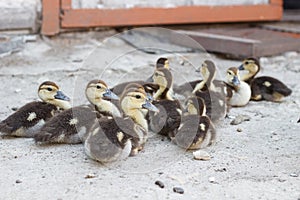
[[41, 0, 60, 36]]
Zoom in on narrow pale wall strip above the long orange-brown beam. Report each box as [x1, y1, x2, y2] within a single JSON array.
[[72, 0, 269, 8]]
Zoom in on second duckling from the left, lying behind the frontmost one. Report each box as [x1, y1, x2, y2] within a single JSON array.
[[34, 80, 121, 144]]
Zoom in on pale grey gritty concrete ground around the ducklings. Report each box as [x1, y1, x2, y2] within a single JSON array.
[[0, 28, 300, 200]]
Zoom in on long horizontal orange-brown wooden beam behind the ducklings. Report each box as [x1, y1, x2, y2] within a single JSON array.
[[61, 4, 282, 28]]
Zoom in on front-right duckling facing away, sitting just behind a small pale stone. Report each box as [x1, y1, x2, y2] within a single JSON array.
[[173, 97, 216, 150]]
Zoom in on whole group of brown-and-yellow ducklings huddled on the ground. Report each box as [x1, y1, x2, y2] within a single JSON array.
[[0, 58, 292, 163]]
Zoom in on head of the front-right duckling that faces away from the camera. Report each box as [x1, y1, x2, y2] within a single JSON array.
[[186, 96, 206, 116]]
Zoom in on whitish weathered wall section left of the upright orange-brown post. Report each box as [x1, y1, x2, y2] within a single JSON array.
[[0, 0, 41, 31]]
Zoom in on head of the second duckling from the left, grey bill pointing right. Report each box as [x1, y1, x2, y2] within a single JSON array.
[[85, 80, 119, 105]]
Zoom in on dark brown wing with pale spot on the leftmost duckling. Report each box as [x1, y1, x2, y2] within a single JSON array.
[[0, 101, 57, 135]]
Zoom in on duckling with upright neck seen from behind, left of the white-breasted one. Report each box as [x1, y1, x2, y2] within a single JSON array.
[[174, 60, 227, 122]]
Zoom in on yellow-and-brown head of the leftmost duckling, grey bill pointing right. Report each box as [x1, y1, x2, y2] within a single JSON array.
[[38, 81, 71, 109]]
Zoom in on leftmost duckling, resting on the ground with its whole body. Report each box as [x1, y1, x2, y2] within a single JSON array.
[[0, 81, 71, 137]]
